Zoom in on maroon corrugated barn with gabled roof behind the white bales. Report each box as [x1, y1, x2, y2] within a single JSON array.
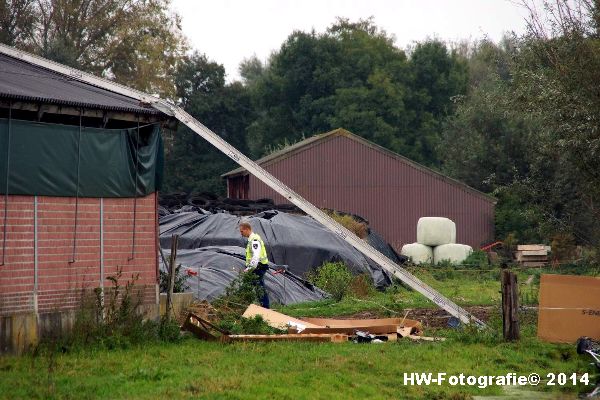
[[223, 129, 495, 250]]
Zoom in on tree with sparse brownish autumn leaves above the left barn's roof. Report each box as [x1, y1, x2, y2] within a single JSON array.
[[0, 0, 186, 98]]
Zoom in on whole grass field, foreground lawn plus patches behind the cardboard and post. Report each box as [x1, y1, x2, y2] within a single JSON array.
[[0, 271, 598, 399]]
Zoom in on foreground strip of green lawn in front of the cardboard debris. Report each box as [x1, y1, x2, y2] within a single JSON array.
[[0, 328, 592, 399]]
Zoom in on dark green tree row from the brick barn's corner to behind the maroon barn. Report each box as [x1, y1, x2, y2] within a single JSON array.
[[167, 19, 468, 193]]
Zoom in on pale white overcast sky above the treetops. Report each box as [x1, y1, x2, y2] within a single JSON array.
[[173, 0, 526, 81]]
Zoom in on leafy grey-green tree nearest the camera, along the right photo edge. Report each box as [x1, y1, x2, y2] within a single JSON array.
[[513, 0, 600, 246]]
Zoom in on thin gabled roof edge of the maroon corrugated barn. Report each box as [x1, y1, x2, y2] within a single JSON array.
[[221, 128, 496, 203]]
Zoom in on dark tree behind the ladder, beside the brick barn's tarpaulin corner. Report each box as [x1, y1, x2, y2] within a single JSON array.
[[165, 53, 253, 195]]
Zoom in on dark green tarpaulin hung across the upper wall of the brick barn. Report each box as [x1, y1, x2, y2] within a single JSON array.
[[0, 119, 163, 197]]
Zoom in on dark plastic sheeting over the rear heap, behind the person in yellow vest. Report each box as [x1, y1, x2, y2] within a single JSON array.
[[160, 211, 402, 288]]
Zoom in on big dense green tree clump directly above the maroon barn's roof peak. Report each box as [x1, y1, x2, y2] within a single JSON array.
[[242, 19, 467, 165]]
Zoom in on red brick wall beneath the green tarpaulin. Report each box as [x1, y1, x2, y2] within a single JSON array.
[[0, 194, 157, 315]]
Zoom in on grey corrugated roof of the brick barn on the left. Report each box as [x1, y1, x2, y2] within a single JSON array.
[[0, 54, 160, 114]]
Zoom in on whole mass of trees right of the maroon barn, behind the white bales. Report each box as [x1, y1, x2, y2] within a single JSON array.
[[442, 0, 600, 253]]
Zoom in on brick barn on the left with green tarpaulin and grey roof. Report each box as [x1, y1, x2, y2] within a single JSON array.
[[0, 50, 173, 352]]
